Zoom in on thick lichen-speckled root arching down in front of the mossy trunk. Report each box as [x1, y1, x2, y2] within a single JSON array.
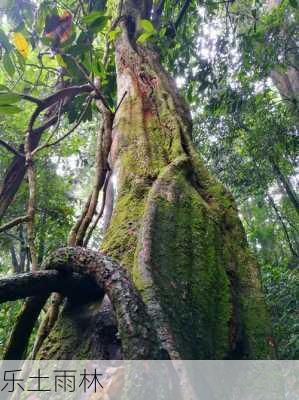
[[44, 247, 168, 359]]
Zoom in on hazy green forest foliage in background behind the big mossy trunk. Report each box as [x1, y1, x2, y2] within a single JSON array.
[[0, 0, 299, 359]]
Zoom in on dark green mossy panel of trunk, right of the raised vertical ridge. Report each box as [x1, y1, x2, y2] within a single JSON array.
[[148, 173, 230, 358]]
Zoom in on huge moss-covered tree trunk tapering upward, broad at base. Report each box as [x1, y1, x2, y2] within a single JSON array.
[[39, 0, 273, 359]]
